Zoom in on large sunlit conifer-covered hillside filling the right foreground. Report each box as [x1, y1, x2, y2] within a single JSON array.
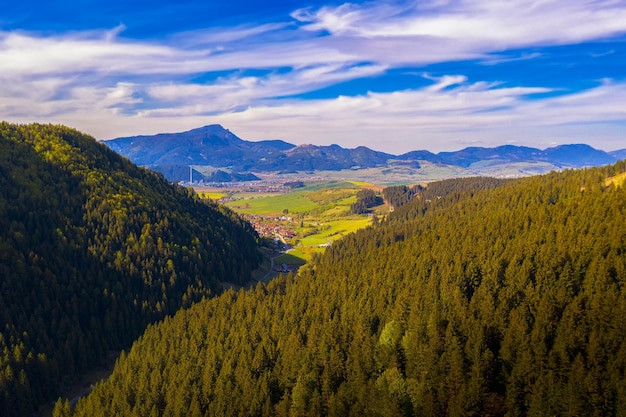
[[64, 162, 626, 416]]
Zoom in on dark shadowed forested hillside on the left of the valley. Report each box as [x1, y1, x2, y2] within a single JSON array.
[[0, 123, 259, 417]]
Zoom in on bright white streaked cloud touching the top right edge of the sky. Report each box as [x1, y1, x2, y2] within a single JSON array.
[[293, 0, 626, 50]]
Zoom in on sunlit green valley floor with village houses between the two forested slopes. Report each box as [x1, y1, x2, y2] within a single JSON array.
[[194, 178, 390, 272]]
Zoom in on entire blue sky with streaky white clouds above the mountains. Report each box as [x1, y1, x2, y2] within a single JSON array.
[[0, 0, 626, 154]]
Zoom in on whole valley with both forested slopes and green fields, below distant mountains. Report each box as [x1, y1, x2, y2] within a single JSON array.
[[0, 123, 626, 417]]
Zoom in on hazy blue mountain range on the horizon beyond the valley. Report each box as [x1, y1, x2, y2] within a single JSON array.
[[104, 125, 626, 182]]
